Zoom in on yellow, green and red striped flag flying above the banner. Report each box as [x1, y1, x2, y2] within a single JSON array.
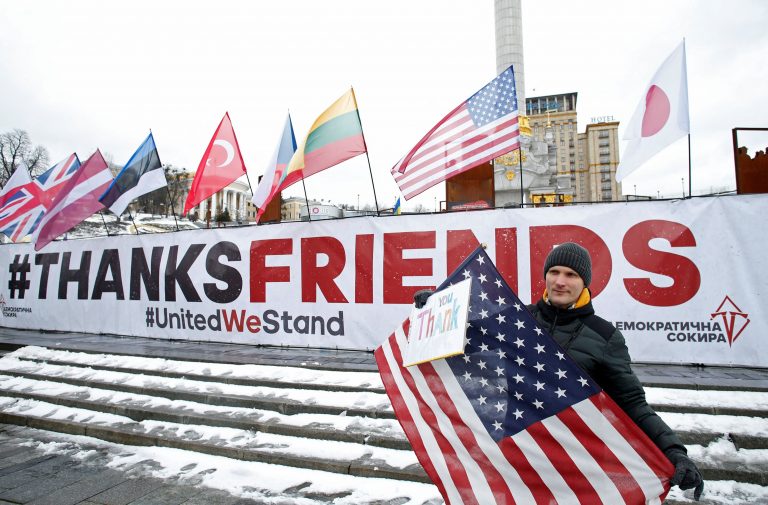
[[280, 88, 366, 191]]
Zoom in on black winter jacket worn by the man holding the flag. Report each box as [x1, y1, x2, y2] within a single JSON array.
[[528, 300, 685, 451]]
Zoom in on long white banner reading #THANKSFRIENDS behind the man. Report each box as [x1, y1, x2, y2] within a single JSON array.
[[0, 195, 768, 366]]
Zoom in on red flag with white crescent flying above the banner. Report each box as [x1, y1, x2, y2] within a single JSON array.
[[183, 112, 245, 214]]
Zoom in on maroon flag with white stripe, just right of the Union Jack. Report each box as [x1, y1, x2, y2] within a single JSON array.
[[34, 149, 112, 251]]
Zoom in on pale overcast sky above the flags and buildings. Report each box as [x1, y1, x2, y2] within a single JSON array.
[[0, 0, 768, 208]]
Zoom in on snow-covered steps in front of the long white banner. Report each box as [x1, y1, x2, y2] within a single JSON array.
[[0, 351, 768, 503]]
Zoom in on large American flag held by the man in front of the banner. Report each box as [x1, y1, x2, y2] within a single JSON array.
[[375, 248, 674, 505]]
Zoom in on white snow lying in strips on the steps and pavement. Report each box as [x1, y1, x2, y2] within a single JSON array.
[[0, 347, 768, 505]]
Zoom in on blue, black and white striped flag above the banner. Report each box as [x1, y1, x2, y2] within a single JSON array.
[[99, 133, 168, 216]]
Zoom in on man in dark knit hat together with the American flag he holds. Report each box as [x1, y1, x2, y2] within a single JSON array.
[[402, 243, 704, 505]]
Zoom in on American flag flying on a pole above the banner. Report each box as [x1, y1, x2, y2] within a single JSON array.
[[392, 67, 520, 200]]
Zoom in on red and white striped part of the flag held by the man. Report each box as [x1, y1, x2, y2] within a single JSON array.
[[375, 320, 671, 505]]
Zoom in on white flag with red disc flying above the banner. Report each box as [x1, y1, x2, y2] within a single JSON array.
[[616, 40, 691, 182]]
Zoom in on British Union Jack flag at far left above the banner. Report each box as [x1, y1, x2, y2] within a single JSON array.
[[0, 153, 80, 242]]
